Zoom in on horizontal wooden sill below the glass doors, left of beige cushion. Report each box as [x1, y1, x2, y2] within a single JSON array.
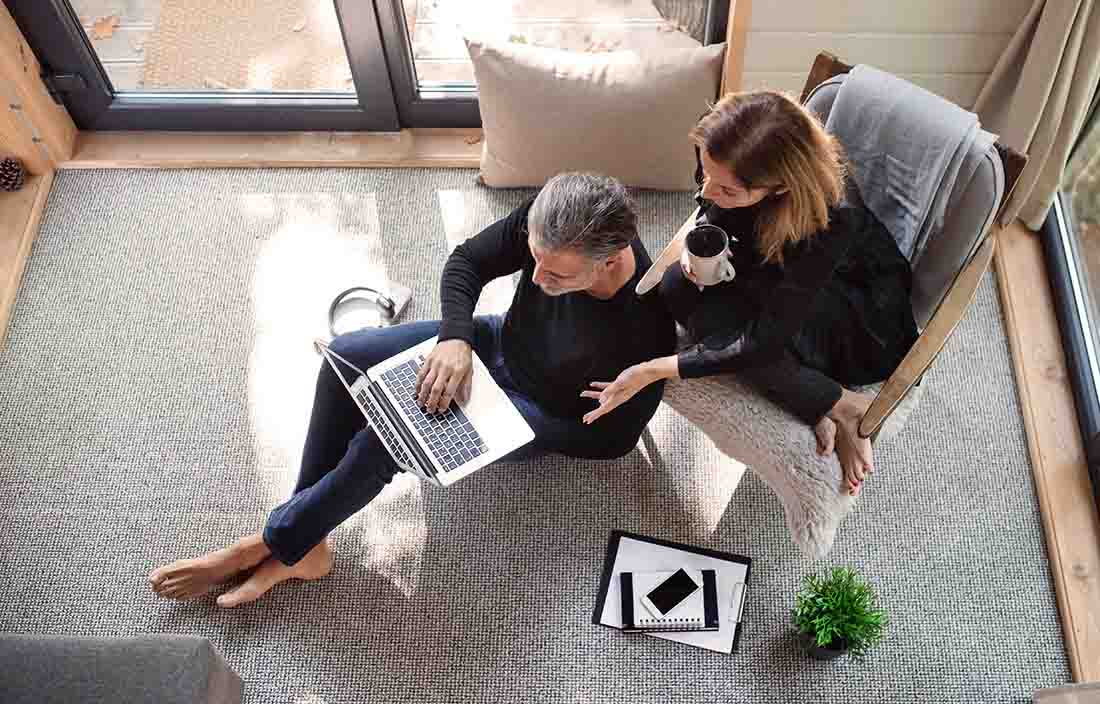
[[61, 129, 482, 168]]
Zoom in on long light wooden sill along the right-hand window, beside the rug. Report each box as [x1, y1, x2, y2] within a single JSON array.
[[993, 220, 1100, 682]]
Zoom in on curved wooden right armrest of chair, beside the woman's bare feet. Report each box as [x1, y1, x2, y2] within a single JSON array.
[[859, 237, 994, 438]]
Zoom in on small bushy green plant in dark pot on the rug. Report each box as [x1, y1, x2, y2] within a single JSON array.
[[792, 568, 887, 660]]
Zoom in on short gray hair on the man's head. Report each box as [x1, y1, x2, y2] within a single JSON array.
[[527, 174, 638, 261]]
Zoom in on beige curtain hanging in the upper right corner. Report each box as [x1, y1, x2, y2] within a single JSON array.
[[975, 0, 1100, 230]]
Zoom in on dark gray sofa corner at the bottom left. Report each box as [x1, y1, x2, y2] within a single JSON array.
[[0, 634, 242, 704]]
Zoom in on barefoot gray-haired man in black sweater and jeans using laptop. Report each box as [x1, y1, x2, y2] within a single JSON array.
[[149, 174, 675, 607]]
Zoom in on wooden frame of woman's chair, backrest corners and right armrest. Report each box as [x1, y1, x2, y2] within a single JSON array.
[[801, 52, 1027, 440]]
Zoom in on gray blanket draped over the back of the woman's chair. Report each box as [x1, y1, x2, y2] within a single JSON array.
[[825, 64, 992, 264]]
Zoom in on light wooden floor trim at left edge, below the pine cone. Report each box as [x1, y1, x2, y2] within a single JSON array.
[[0, 172, 54, 348]]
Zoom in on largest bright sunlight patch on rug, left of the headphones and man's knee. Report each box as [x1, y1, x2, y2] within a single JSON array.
[[247, 193, 388, 504]]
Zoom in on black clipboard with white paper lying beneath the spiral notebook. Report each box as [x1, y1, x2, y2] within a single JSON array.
[[592, 530, 752, 655]]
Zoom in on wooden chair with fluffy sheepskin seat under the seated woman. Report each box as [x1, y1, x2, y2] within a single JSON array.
[[664, 53, 1026, 557]]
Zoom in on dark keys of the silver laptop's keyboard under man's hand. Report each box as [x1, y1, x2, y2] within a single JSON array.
[[382, 358, 488, 472]]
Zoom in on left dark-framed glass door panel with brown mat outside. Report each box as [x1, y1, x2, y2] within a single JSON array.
[[6, 0, 400, 131]]
